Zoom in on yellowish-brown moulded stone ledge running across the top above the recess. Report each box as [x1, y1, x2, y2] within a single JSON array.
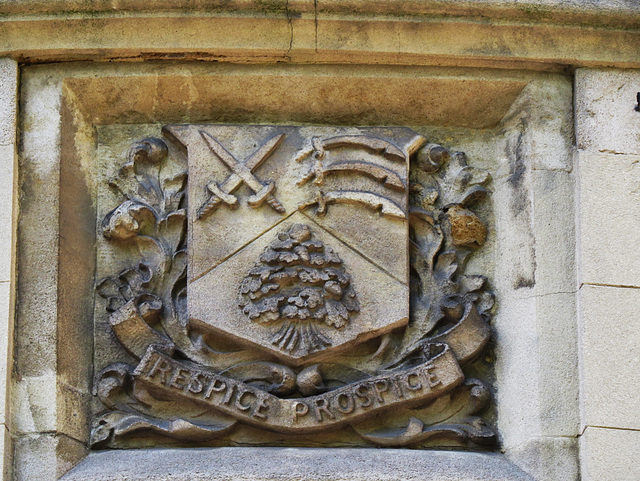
[[0, 0, 638, 68]]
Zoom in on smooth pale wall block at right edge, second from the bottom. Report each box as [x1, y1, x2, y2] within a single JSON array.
[[579, 286, 640, 430]]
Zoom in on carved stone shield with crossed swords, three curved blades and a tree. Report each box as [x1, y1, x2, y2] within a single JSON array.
[[165, 125, 418, 365]]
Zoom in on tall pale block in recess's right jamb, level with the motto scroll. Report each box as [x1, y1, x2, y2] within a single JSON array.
[[493, 293, 579, 446]]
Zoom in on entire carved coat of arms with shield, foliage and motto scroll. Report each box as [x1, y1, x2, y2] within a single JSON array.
[[92, 124, 495, 447]]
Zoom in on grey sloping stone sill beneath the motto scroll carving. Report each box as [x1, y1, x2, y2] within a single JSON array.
[[62, 448, 533, 481]]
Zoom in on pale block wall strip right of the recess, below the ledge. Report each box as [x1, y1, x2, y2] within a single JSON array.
[[575, 69, 640, 479]]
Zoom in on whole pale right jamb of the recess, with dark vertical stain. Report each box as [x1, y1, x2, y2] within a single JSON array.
[[488, 103, 579, 460]]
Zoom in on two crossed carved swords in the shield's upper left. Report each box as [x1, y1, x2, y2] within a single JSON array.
[[198, 130, 285, 219]]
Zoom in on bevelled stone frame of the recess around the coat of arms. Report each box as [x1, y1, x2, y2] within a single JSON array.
[[10, 64, 578, 480]]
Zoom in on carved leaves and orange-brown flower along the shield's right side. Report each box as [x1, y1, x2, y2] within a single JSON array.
[[410, 144, 493, 342]]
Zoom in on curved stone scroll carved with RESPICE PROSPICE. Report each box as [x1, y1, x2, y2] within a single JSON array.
[[133, 344, 464, 434]]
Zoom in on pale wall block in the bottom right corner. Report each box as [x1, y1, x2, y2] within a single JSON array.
[[580, 427, 640, 481]]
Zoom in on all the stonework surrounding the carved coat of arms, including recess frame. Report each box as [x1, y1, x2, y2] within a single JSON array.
[[0, 0, 640, 481]]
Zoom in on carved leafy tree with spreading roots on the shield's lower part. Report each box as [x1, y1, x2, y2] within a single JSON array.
[[238, 224, 360, 352]]
